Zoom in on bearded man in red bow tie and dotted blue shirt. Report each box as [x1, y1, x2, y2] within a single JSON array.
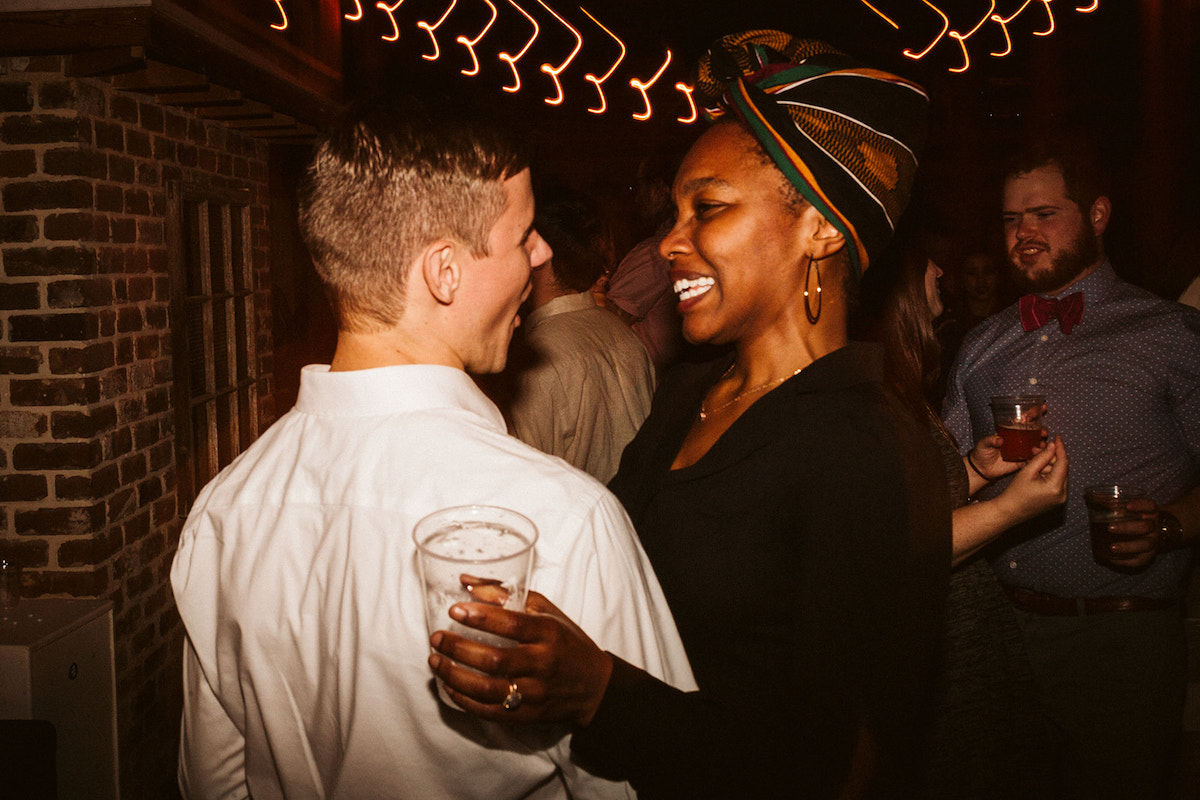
[[943, 138, 1200, 800]]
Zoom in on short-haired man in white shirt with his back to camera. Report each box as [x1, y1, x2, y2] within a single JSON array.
[[172, 100, 694, 800]]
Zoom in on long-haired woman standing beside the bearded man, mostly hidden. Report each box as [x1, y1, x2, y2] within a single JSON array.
[[854, 230, 1068, 800]]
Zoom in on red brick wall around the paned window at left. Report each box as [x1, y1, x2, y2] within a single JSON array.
[[0, 58, 274, 798]]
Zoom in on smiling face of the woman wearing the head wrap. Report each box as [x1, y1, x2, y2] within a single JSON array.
[[659, 122, 820, 344]]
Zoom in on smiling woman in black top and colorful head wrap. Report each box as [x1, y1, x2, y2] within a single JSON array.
[[431, 31, 950, 798]]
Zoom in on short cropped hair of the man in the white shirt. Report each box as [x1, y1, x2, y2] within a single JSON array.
[[300, 100, 528, 330]]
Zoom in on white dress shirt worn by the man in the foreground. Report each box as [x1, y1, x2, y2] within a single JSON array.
[[170, 366, 695, 800]]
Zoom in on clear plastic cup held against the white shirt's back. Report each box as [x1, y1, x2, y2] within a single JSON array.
[[413, 505, 538, 708]]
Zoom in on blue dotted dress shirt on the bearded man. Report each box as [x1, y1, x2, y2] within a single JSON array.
[[943, 263, 1200, 597]]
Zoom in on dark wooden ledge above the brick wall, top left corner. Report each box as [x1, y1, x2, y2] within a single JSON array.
[[0, 0, 343, 138]]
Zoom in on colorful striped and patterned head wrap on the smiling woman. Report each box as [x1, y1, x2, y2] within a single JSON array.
[[696, 30, 929, 276]]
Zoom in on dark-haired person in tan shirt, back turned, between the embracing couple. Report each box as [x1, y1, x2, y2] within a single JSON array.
[[506, 190, 654, 482]]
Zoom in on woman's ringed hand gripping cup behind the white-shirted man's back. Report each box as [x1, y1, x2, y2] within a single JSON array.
[[430, 591, 612, 726]]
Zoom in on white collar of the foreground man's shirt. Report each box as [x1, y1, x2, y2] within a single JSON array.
[[295, 363, 506, 432]]
